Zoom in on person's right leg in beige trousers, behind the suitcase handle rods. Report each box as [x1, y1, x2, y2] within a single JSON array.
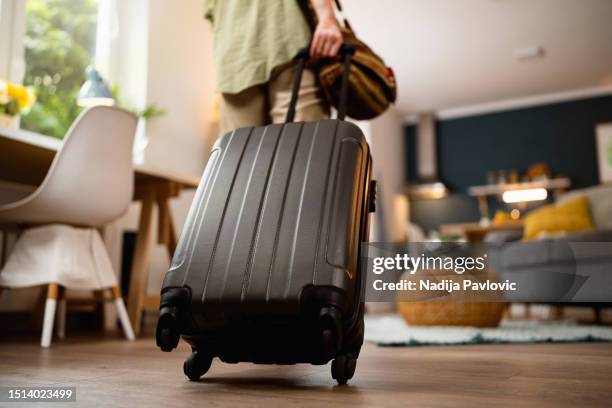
[[268, 64, 329, 123]]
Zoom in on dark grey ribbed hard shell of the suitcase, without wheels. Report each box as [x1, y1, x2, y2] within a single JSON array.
[[164, 120, 371, 312]]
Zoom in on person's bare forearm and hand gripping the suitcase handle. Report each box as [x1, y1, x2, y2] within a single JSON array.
[[310, 0, 342, 59]]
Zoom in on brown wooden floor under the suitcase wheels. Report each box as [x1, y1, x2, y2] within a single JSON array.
[[0, 337, 612, 408]]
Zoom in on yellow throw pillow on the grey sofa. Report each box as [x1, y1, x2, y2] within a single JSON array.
[[523, 196, 593, 240]]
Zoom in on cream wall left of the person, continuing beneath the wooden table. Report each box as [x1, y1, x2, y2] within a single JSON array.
[[139, 0, 216, 293]]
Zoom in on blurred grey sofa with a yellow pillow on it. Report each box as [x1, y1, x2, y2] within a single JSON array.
[[485, 185, 612, 306]]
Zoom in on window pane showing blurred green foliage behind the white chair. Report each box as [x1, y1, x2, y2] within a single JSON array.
[[21, 0, 98, 138]]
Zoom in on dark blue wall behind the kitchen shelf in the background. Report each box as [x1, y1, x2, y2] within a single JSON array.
[[405, 96, 612, 230]]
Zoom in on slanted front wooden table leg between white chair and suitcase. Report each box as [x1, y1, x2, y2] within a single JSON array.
[[128, 195, 155, 336]]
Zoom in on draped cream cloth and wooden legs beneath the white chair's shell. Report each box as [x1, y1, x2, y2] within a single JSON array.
[[0, 224, 134, 347]]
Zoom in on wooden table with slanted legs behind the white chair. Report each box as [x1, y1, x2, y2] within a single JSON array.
[[0, 117, 199, 336]]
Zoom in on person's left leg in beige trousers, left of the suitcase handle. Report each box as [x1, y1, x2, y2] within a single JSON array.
[[219, 86, 269, 136]]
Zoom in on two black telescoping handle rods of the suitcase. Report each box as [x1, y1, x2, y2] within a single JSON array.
[[285, 44, 355, 123]]
